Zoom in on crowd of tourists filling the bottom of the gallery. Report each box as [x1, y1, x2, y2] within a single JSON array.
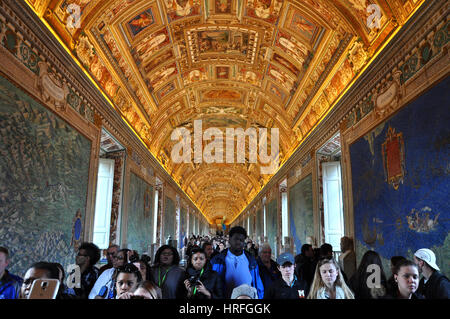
[[0, 226, 450, 299]]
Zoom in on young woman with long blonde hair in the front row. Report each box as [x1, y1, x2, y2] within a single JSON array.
[[308, 258, 355, 299]]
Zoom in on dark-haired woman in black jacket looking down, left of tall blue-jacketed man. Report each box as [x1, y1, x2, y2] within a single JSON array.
[[184, 247, 223, 299]]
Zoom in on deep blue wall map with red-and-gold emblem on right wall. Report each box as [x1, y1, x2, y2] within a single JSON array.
[[350, 79, 450, 276]]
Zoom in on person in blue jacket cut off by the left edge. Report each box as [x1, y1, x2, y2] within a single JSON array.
[[0, 247, 23, 299]]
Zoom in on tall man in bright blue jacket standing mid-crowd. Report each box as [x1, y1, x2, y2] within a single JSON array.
[[211, 226, 264, 299]]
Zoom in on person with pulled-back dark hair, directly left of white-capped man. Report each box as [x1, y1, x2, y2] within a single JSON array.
[[385, 259, 424, 299]]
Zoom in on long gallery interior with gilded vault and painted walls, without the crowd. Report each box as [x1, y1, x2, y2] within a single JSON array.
[[0, 0, 450, 304]]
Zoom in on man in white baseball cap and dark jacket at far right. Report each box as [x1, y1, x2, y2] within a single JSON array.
[[414, 248, 450, 299]]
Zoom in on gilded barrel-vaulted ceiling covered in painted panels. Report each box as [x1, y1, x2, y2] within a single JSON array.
[[27, 0, 423, 223]]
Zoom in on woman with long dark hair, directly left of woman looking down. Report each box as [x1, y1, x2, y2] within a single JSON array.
[[151, 245, 185, 299]]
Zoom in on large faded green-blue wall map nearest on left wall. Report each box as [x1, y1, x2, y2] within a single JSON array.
[[0, 77, 91, 276]]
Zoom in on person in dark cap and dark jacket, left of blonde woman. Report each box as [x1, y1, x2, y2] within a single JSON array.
[[264, 253, 309, 299]]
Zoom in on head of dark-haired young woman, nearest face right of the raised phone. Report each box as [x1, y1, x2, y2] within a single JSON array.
[[113, 263, 142, 299]]
